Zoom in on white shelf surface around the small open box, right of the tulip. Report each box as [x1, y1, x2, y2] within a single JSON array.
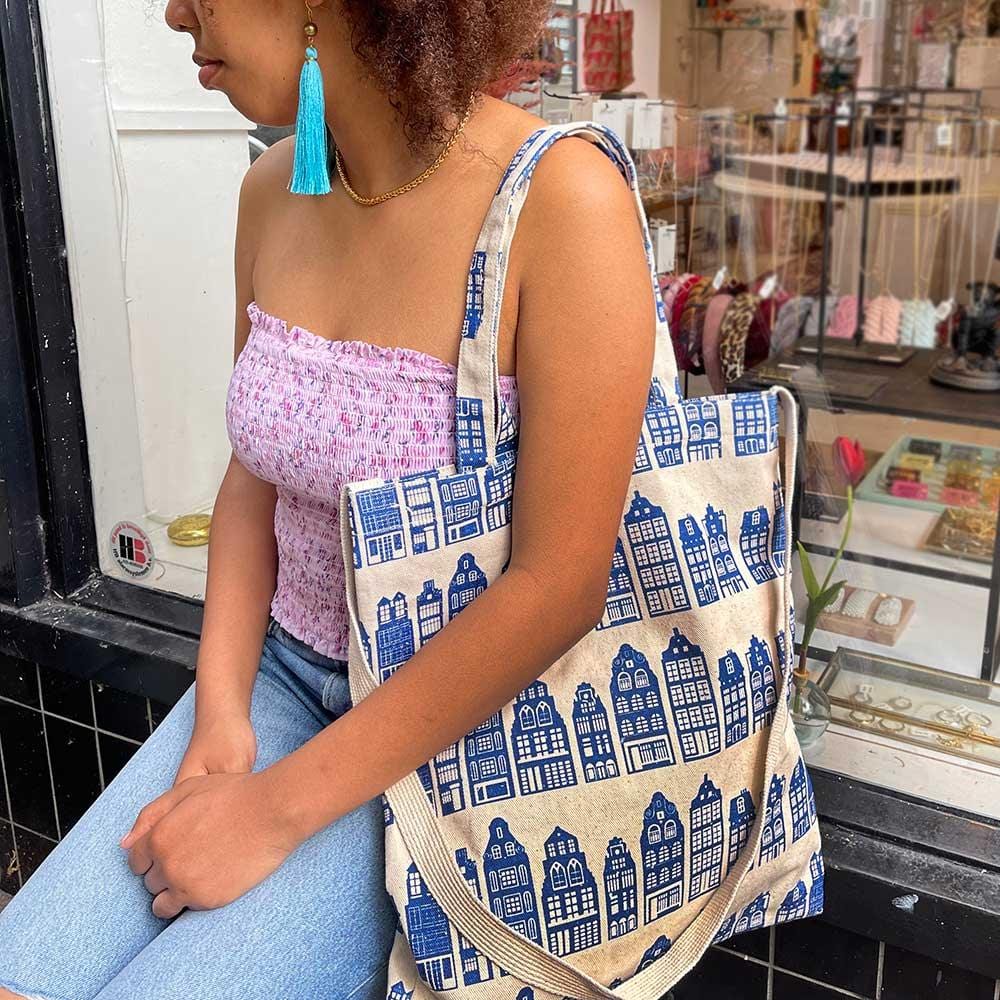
[[792, 553, 989, 677]]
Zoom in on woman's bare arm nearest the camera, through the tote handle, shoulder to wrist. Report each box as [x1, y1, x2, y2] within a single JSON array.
[[261, 139, 656, 840]]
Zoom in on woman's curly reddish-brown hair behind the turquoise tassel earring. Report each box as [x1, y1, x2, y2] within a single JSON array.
[[340, 0, 552, 152]]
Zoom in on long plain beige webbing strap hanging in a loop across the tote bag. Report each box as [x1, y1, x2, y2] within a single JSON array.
[[348, 384, 798, 1000]]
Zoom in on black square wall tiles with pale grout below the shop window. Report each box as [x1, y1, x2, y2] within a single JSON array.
[[0, 656, 1000, 1000]]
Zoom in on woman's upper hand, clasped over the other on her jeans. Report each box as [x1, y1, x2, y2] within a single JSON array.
[[121, 770, 301, 919]]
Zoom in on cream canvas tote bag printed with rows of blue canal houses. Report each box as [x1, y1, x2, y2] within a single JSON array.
[[340, 122, 823, 1000]]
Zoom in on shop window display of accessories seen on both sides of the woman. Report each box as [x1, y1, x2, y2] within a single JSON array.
[[43, 0, 1000, 809]]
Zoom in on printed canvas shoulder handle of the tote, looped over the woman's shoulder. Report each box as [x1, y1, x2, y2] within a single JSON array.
[[455, 121, 680, 472]]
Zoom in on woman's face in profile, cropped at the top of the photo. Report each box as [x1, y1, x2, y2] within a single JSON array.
[[164, 0, 324, 126]]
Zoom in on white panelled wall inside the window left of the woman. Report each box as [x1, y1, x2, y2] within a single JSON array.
[[41, 0, 254, 573]]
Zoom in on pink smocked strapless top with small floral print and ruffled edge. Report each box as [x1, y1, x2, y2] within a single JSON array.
[[226, 302, 518, 660]]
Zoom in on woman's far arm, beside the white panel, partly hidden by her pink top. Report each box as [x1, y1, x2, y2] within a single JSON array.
[[195, 151, 278, 728]]
